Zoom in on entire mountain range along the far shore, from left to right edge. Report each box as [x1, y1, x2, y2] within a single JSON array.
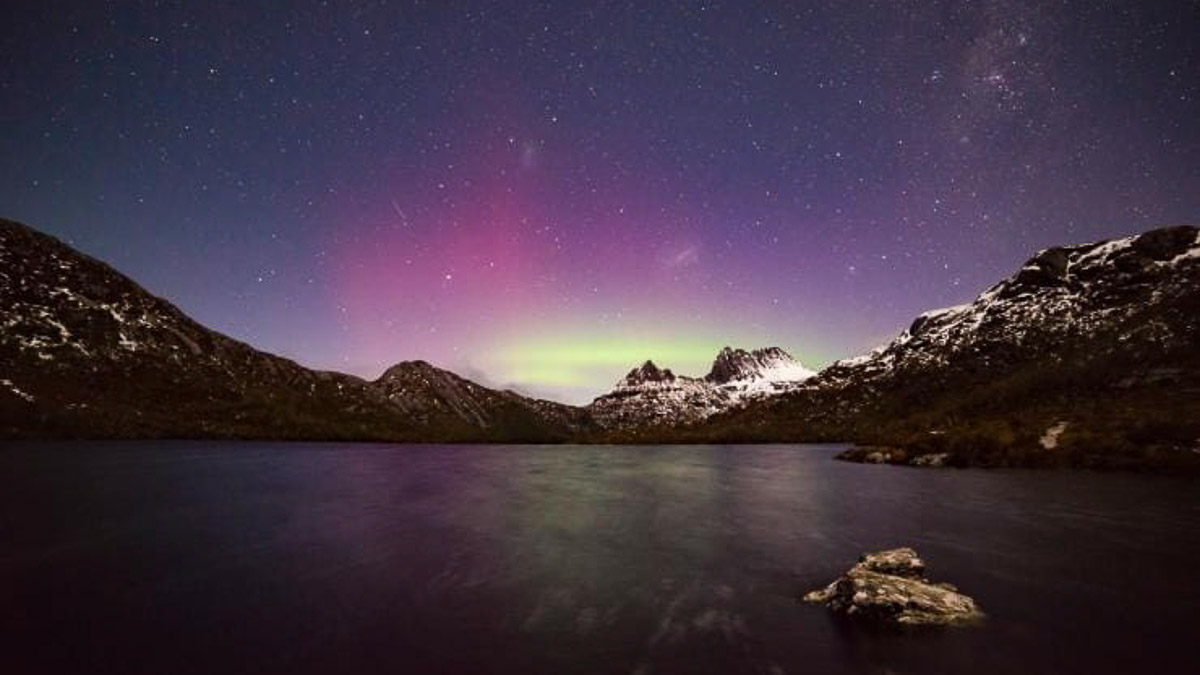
[[0, 214, 1200, 466]]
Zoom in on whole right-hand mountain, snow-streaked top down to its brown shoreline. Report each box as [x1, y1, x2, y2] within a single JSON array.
[[690, 226, 1200, 466]]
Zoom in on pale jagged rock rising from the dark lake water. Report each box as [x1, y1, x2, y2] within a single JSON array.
[[804, 548, 984, 626]]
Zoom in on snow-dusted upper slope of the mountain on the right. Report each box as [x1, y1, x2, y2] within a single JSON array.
[[806, 226, 1200, 388]]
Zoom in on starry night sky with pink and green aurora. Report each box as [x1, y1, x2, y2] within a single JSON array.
[[0, 0, 1200, 402]]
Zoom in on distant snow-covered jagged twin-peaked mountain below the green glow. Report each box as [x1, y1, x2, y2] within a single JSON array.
[[587, 347, 815, 430]]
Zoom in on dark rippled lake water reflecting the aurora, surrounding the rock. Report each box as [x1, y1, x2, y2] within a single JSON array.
[[0, 442, 1200, 675]]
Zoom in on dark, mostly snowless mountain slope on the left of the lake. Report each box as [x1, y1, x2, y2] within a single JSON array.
[[0, 219, 587, 441]]
